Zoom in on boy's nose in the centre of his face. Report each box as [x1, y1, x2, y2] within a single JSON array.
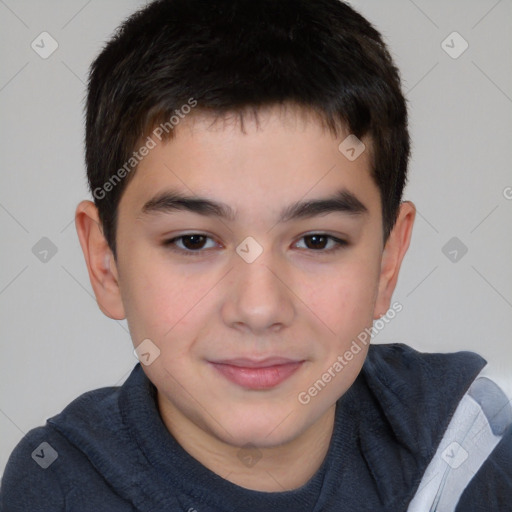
[[222, 251, 295, 334]]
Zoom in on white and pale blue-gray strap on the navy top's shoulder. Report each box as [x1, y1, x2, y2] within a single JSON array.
[[407, 376, 512, 512]]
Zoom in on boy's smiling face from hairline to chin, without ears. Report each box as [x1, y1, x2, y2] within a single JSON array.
[[102, 109, 396, 447]]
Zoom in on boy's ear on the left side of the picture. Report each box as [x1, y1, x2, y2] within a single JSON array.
[[75, 201, 126, 320]]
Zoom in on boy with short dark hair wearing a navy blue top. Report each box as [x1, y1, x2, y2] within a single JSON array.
[[1, 0, 512, 512]]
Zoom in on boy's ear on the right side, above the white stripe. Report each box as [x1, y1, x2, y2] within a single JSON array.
[[373, 201, 416, 319]]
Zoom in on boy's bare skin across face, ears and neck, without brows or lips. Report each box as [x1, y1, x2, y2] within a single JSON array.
[[76, 107, 415, 492]]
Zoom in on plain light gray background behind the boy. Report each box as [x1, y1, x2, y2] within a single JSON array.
[[0, 0, 512, 476]]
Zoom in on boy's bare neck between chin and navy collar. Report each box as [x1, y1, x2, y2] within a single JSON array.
[[157, 393, 336, 492]]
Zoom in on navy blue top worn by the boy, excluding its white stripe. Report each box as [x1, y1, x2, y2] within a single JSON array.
[[0, 343, 512, 512]]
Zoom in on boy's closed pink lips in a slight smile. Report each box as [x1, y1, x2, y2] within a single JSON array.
[[209, 358, 304, 390]]
